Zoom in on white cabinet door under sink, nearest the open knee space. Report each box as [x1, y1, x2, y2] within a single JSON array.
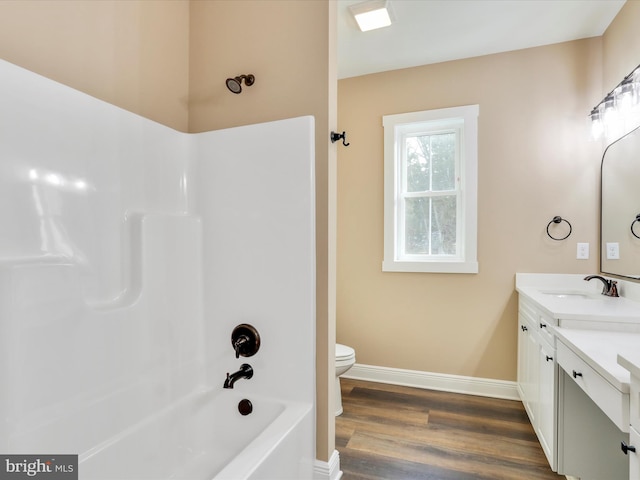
[[537, 343, 558, 472]]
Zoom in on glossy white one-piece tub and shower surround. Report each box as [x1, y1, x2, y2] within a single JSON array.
[[0, 61, 315, 479]]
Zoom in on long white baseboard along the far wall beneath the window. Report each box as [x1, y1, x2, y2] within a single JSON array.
[[342, 363, 520, 400]]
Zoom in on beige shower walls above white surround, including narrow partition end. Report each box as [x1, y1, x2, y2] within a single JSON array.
[[0, 0, 337, 461]]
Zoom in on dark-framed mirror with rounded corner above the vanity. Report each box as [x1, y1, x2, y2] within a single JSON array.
[[600, 128, 640, 279]]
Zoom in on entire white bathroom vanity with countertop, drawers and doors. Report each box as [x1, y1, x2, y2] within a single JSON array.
[[516, 273, 640, 480]]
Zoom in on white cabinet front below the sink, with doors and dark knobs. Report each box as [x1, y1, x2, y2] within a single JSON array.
[[517, 297, 558, 472]]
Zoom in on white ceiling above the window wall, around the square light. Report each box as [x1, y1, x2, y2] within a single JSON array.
[[338, 0, 625, 78]]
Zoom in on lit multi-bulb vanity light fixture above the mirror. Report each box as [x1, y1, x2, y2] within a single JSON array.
[[589, 65, 640, 141]]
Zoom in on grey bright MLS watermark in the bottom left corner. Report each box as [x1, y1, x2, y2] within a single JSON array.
[[0, 455, 78, 480]]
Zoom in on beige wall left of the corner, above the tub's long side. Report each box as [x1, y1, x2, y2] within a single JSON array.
[[0, 0, 189, 131]]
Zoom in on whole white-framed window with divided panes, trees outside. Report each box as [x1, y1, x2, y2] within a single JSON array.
[[382, 105, 479, 273]]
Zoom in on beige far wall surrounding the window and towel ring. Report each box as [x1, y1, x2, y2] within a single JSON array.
[[336, 38, 602, 380]]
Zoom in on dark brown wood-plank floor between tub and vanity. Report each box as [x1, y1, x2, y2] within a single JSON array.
[[336, 378, 564, 480]]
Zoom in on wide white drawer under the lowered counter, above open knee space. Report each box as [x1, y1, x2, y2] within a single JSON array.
[[556, 341, 629, 432]]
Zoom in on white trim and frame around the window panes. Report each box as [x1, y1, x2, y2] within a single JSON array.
[[382, 105, 480, 273]]
